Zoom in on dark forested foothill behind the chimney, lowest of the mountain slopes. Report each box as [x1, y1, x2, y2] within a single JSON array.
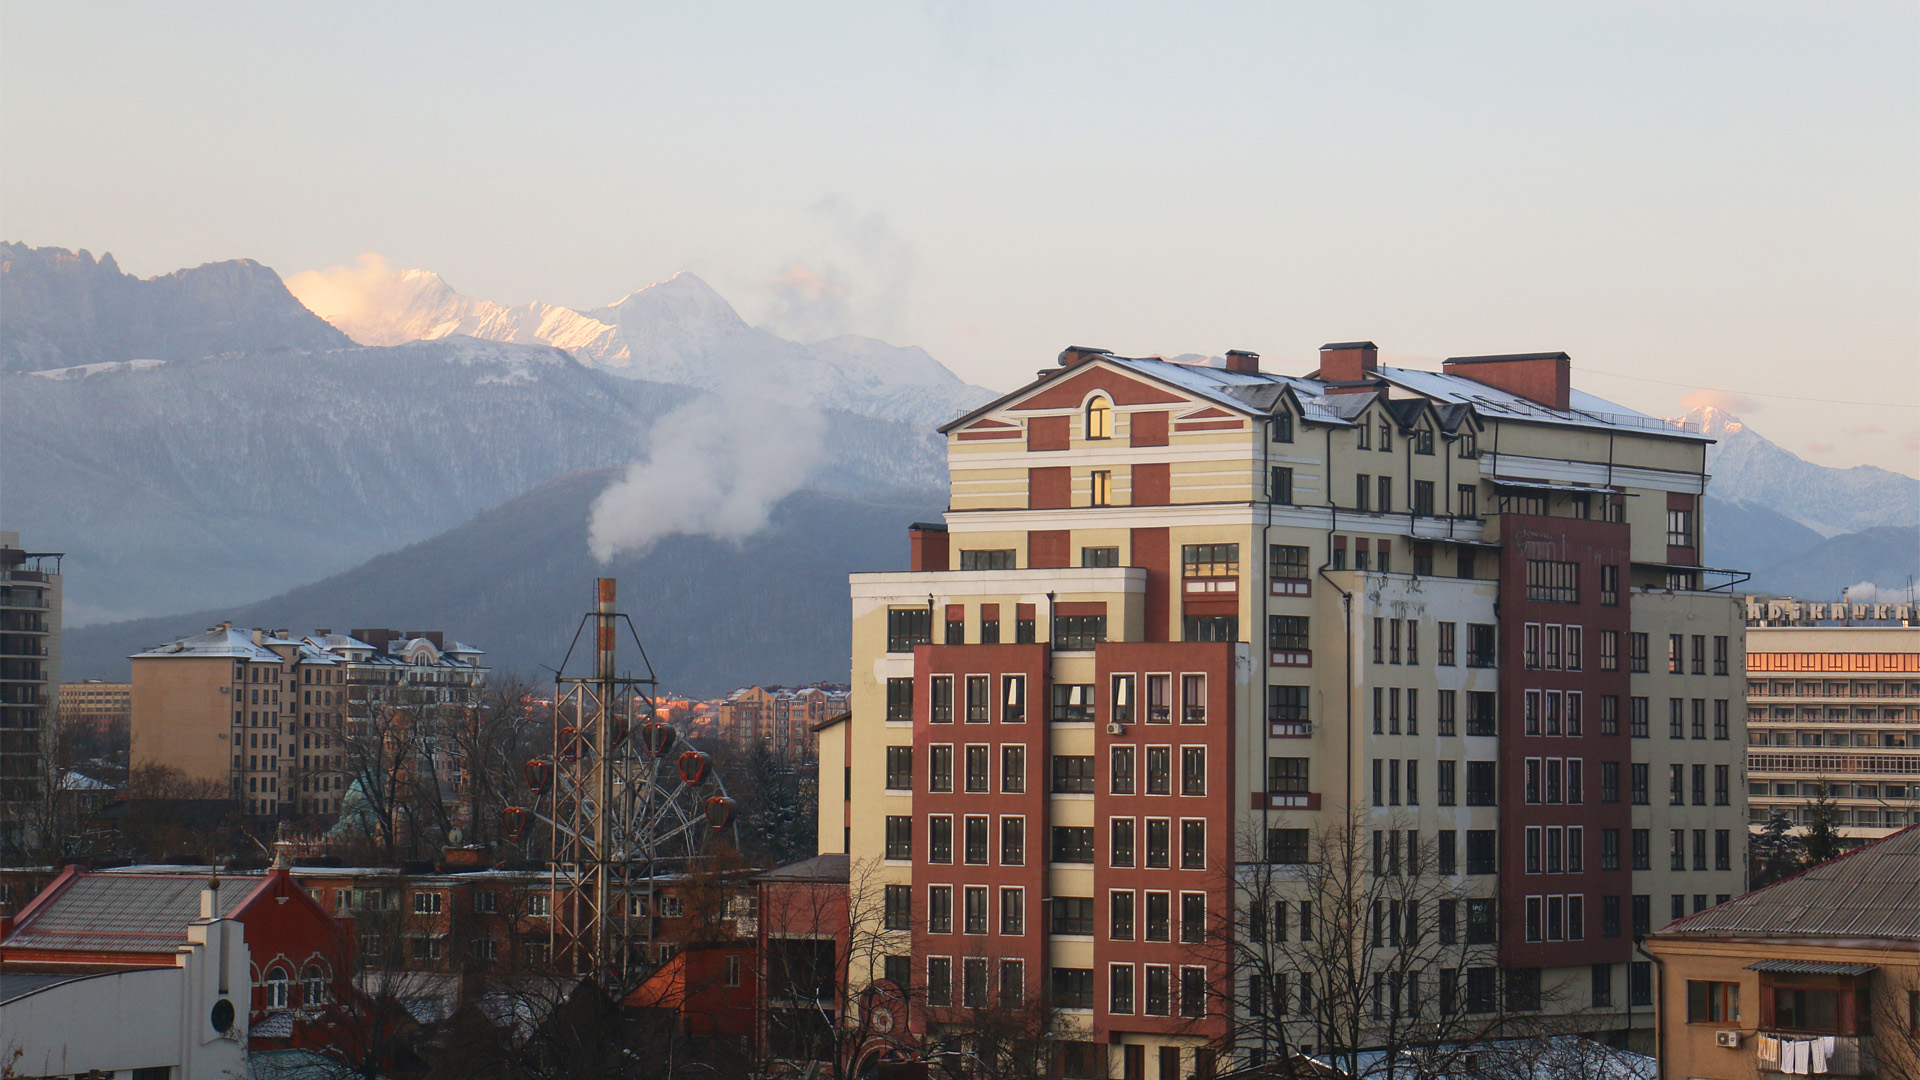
[[63, 469, 943, 694]]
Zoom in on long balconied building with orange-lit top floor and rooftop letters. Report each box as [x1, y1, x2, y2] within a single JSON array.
[[1747, 600, 1920, 844]]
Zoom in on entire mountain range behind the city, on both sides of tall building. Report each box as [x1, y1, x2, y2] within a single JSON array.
[[0, 244, 1920, 694]]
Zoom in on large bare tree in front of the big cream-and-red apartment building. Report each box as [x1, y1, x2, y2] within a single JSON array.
[[1200, 811, 1563, 1078]]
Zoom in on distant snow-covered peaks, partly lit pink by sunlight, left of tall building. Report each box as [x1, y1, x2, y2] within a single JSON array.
[[288, 259, 995, 427]]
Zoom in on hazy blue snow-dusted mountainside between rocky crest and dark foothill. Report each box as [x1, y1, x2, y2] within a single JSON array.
[[0, 338, 945, 623]]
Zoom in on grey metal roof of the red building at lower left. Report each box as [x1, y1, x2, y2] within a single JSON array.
[[6, 874, 259, 953]]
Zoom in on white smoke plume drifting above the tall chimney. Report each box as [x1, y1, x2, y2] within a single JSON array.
[[588, 384, 826, 563]]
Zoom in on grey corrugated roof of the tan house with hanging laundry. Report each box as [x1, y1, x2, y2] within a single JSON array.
[[1661, 824, 1920, 942]]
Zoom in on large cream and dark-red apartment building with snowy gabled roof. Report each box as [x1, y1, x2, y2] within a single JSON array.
[[820, 342, 1747, 1060]]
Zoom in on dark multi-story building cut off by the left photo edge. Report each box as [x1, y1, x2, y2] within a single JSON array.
[[0, 532, 61, 855]]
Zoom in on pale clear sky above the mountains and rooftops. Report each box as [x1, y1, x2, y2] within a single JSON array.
[[0, 0, 1920, 475]]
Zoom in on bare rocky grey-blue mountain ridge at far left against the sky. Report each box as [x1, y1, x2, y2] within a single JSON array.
[[0, 242, 353, 371]]
